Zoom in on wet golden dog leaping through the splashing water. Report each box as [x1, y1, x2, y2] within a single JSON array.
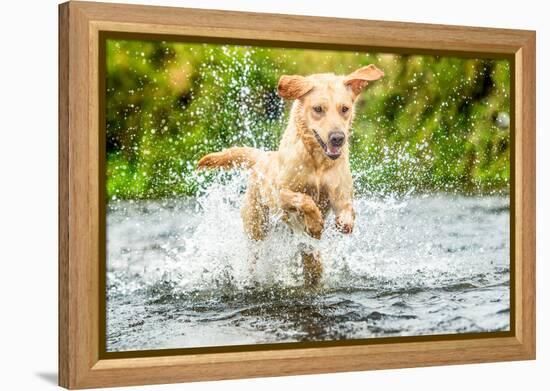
[[198, 64, 384, 286]]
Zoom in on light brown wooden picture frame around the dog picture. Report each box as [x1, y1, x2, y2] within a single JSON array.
[[59, 1, 535, 389]]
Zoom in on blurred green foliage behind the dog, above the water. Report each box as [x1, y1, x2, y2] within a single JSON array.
[[106, 40, 510, 199]]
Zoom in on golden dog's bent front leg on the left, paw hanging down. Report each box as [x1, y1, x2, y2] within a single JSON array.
[[279, 189, 325, 239]]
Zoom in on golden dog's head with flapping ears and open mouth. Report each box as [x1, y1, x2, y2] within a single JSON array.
[[278, 64, 384, 160]]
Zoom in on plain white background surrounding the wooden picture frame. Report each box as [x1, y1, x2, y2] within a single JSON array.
[[0, 0, 550, 391]]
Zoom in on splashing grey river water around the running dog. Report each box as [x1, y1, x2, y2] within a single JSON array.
[[107, 176, 510, 351]]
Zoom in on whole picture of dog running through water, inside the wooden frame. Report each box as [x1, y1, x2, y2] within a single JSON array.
[[103, 38, 512, 352]]
